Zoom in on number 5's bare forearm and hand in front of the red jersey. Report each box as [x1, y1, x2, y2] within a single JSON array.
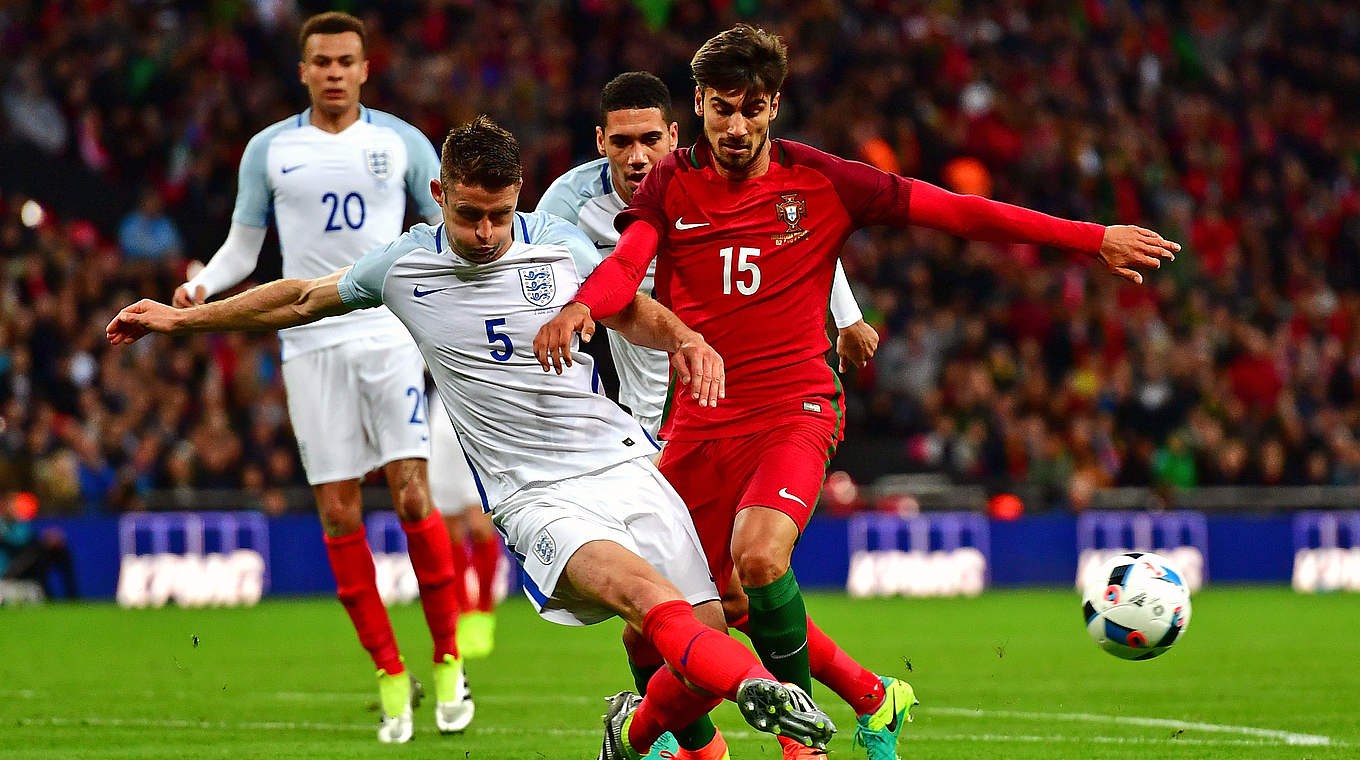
[[601, 292, 728, 407]]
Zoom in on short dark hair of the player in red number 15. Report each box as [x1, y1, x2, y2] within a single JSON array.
[[690, 23, 789, 95]]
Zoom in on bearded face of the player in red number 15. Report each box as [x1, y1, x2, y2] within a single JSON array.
[[694, 87, 779, 178]]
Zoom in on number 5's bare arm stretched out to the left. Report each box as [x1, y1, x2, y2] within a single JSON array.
[[105, 266, 355, 345]]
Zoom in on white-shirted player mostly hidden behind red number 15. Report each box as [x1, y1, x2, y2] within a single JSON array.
[[539, 71, 879, 438]]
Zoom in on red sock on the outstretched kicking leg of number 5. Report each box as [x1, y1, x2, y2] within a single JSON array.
[[642, 600, 774, 701]]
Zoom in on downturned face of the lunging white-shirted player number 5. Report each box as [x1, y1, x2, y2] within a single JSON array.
[[430, 179, 521, 264]]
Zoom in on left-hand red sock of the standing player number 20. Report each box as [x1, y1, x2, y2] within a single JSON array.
[[325, 528, 405, 676]]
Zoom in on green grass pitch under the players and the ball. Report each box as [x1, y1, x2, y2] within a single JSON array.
[[0, 589, 1360, 760]]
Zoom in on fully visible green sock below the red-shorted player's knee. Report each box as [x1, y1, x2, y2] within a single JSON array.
[[743, 568, 812, 695]]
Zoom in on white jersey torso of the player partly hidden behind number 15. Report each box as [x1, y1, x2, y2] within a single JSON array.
[[539, 158, 670, 436]]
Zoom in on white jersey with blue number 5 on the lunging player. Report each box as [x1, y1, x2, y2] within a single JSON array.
[[340, 212, 658, 508]]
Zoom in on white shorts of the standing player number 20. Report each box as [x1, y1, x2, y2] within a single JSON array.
[[283, 336, 430, 485]]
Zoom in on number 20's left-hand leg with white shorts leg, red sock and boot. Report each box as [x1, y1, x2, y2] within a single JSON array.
[[283, 347, 419, 742]]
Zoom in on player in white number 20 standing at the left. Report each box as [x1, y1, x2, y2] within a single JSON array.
[[174, 12, 473, 742]]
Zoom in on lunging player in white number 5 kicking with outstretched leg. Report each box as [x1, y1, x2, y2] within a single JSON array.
[[107, 117, 835, 760]]
